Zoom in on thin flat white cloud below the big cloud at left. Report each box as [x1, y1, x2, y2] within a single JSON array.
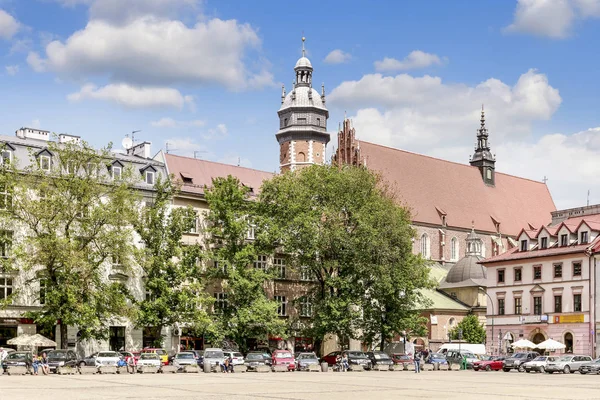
[[67, 83, 193, 109]]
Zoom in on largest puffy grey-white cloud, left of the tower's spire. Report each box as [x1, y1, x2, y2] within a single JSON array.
[[28, 16, 273, 90]]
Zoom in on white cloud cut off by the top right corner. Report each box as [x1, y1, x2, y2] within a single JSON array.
[[505, 0, 600, 39]]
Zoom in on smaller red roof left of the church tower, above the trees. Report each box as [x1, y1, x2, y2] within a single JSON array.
[[165, 154, 274, 194]]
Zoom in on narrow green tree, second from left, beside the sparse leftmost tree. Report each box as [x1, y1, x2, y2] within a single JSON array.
[[133, 179, 216, 346]]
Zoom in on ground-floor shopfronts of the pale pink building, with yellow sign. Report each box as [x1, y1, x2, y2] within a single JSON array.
[[486, 314, 596, 356]]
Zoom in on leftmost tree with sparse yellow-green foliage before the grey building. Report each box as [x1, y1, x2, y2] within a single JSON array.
[[0, 138, 136, 348]]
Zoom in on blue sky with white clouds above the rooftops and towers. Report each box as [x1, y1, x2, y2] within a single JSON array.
[[0, 0, 600, 209]]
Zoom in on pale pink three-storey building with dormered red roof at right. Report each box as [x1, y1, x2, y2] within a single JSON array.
[[482, 206, 600, 355]]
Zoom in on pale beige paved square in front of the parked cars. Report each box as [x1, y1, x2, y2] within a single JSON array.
[[0, 371, 600, 400]]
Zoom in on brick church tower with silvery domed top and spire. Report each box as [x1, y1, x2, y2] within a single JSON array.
[[275, 38, 329, 172]]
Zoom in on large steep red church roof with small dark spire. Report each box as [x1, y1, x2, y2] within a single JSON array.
[[360, 141, 556, 235]]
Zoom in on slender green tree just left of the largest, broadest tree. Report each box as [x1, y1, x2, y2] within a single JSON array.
[[206, 176, 285, 351]]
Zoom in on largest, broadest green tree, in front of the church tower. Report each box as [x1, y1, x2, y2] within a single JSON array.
[[259, 166, 431, 352]]
